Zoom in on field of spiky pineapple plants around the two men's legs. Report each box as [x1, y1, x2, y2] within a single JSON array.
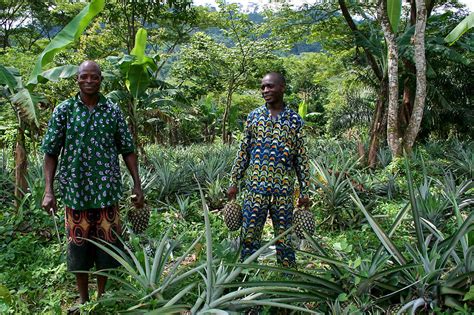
[[0, 138, 474, 314]]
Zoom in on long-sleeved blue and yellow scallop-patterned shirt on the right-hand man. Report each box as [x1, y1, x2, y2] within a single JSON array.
[[231, 105, 309, 197]]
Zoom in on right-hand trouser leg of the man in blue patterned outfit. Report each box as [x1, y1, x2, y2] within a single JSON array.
[[270, 195, 296, 267]]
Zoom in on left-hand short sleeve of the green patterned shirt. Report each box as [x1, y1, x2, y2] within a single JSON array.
[[41, 104, 67, 156]]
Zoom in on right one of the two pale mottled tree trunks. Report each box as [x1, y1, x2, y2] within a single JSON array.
[[403, 0, 426, 151]]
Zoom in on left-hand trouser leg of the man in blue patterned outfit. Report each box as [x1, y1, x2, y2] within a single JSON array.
[[240, 192, 269, 261]]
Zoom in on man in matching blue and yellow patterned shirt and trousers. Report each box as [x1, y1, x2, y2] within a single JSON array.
[[227, 72, 309, 266]]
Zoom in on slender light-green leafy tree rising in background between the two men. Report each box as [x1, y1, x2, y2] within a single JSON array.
[[173, 2, 279, 143]]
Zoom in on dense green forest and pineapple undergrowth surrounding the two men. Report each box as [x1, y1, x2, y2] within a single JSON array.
[[0, 0, 474, 314]]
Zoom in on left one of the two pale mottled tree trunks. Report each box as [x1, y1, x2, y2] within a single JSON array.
[[377, 0, 402, 157]]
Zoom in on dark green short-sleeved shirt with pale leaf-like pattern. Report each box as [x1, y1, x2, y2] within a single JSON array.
[[41, 94, 135, 210]]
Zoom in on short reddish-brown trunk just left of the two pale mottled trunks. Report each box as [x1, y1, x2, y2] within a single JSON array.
[[367, 80, 388, 168]]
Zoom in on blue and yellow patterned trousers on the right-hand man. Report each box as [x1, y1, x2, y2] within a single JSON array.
[[240, 192, 296, 267]]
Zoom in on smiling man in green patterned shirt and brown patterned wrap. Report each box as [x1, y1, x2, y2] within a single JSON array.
[[42, 61, 144, 303]]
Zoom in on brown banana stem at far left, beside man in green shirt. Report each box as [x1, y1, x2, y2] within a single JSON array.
[[15, 125, 28, 208]]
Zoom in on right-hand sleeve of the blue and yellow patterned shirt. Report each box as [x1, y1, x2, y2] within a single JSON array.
[[295, 123, 309, 198]]
